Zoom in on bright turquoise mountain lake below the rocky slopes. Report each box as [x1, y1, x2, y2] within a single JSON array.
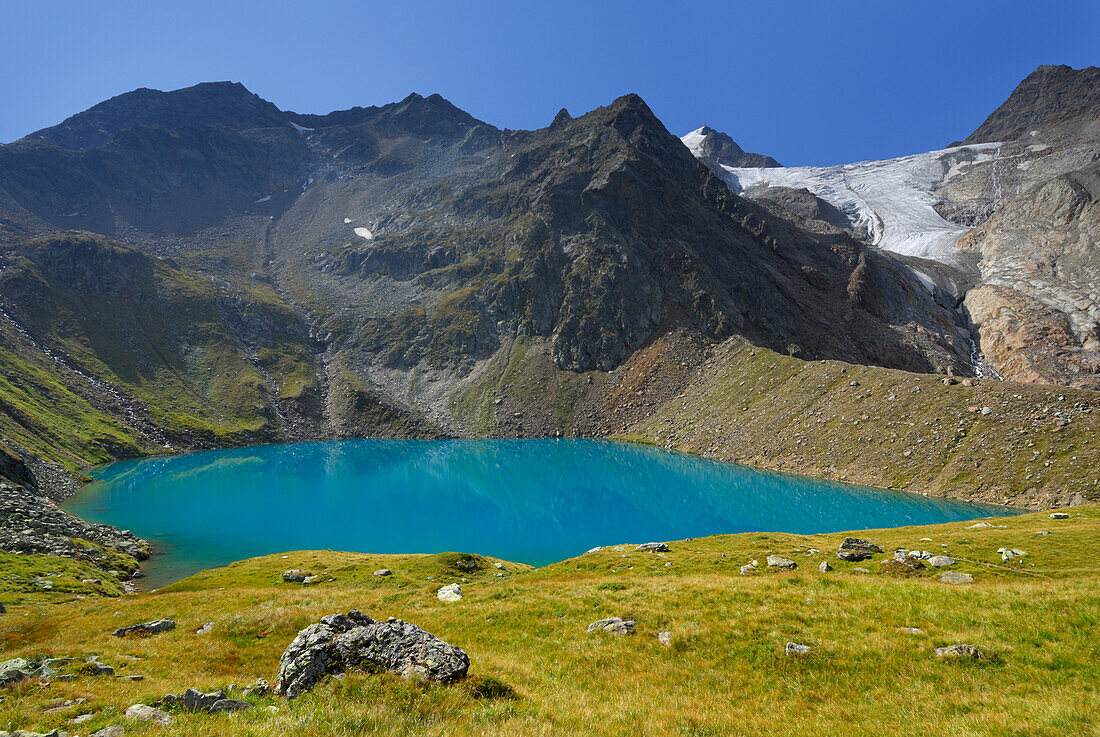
[[64, 439, 1013, 587]]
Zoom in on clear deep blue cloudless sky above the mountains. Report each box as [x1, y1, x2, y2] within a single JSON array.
[[0, 0, 1100, 165]]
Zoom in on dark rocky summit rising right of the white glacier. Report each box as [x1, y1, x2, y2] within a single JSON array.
[[952, 65, 1100, 145]]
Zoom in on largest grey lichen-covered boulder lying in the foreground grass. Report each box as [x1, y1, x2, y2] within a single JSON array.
[[275, 609, 470, 699]]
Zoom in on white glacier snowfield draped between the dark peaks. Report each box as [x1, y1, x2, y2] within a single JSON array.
[[681, 131, 1003, 262]]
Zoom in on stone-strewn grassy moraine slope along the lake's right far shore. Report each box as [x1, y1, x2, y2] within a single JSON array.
[[620, 338, 1100, 508]]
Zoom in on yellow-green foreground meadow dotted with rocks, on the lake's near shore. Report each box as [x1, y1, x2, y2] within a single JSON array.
[[0, 505, 1100, 736]]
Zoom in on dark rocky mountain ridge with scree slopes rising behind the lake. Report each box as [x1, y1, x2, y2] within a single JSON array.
[[0, 69, 1086, 514]]
